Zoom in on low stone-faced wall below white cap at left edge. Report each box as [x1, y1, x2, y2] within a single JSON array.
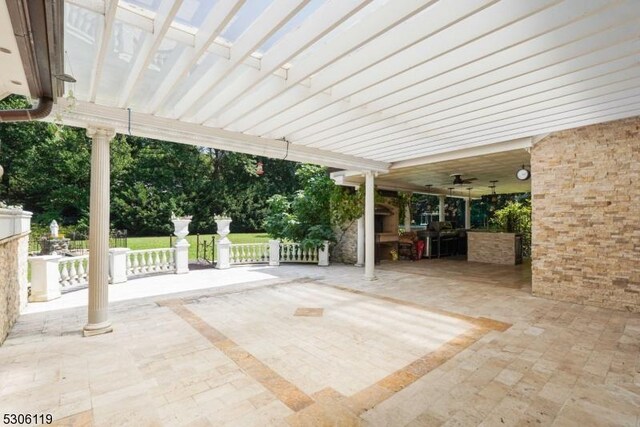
[[0, 233, 29, 345]]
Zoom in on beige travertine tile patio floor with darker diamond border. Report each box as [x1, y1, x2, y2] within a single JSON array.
[[0, 260, 640, 426]]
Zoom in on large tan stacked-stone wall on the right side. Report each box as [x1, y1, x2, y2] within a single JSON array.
[[531, 117, 640, 312]]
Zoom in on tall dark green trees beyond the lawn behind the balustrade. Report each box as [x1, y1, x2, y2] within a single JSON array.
[[0, 97, 300, 235]]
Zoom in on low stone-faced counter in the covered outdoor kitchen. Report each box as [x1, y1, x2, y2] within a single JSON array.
[[467, 230, 522, 265]]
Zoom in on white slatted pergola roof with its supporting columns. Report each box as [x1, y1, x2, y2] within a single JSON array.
[[0, 0, 640, 331]]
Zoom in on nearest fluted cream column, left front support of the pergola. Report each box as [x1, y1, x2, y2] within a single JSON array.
[[84, 127, 115, 336]]
